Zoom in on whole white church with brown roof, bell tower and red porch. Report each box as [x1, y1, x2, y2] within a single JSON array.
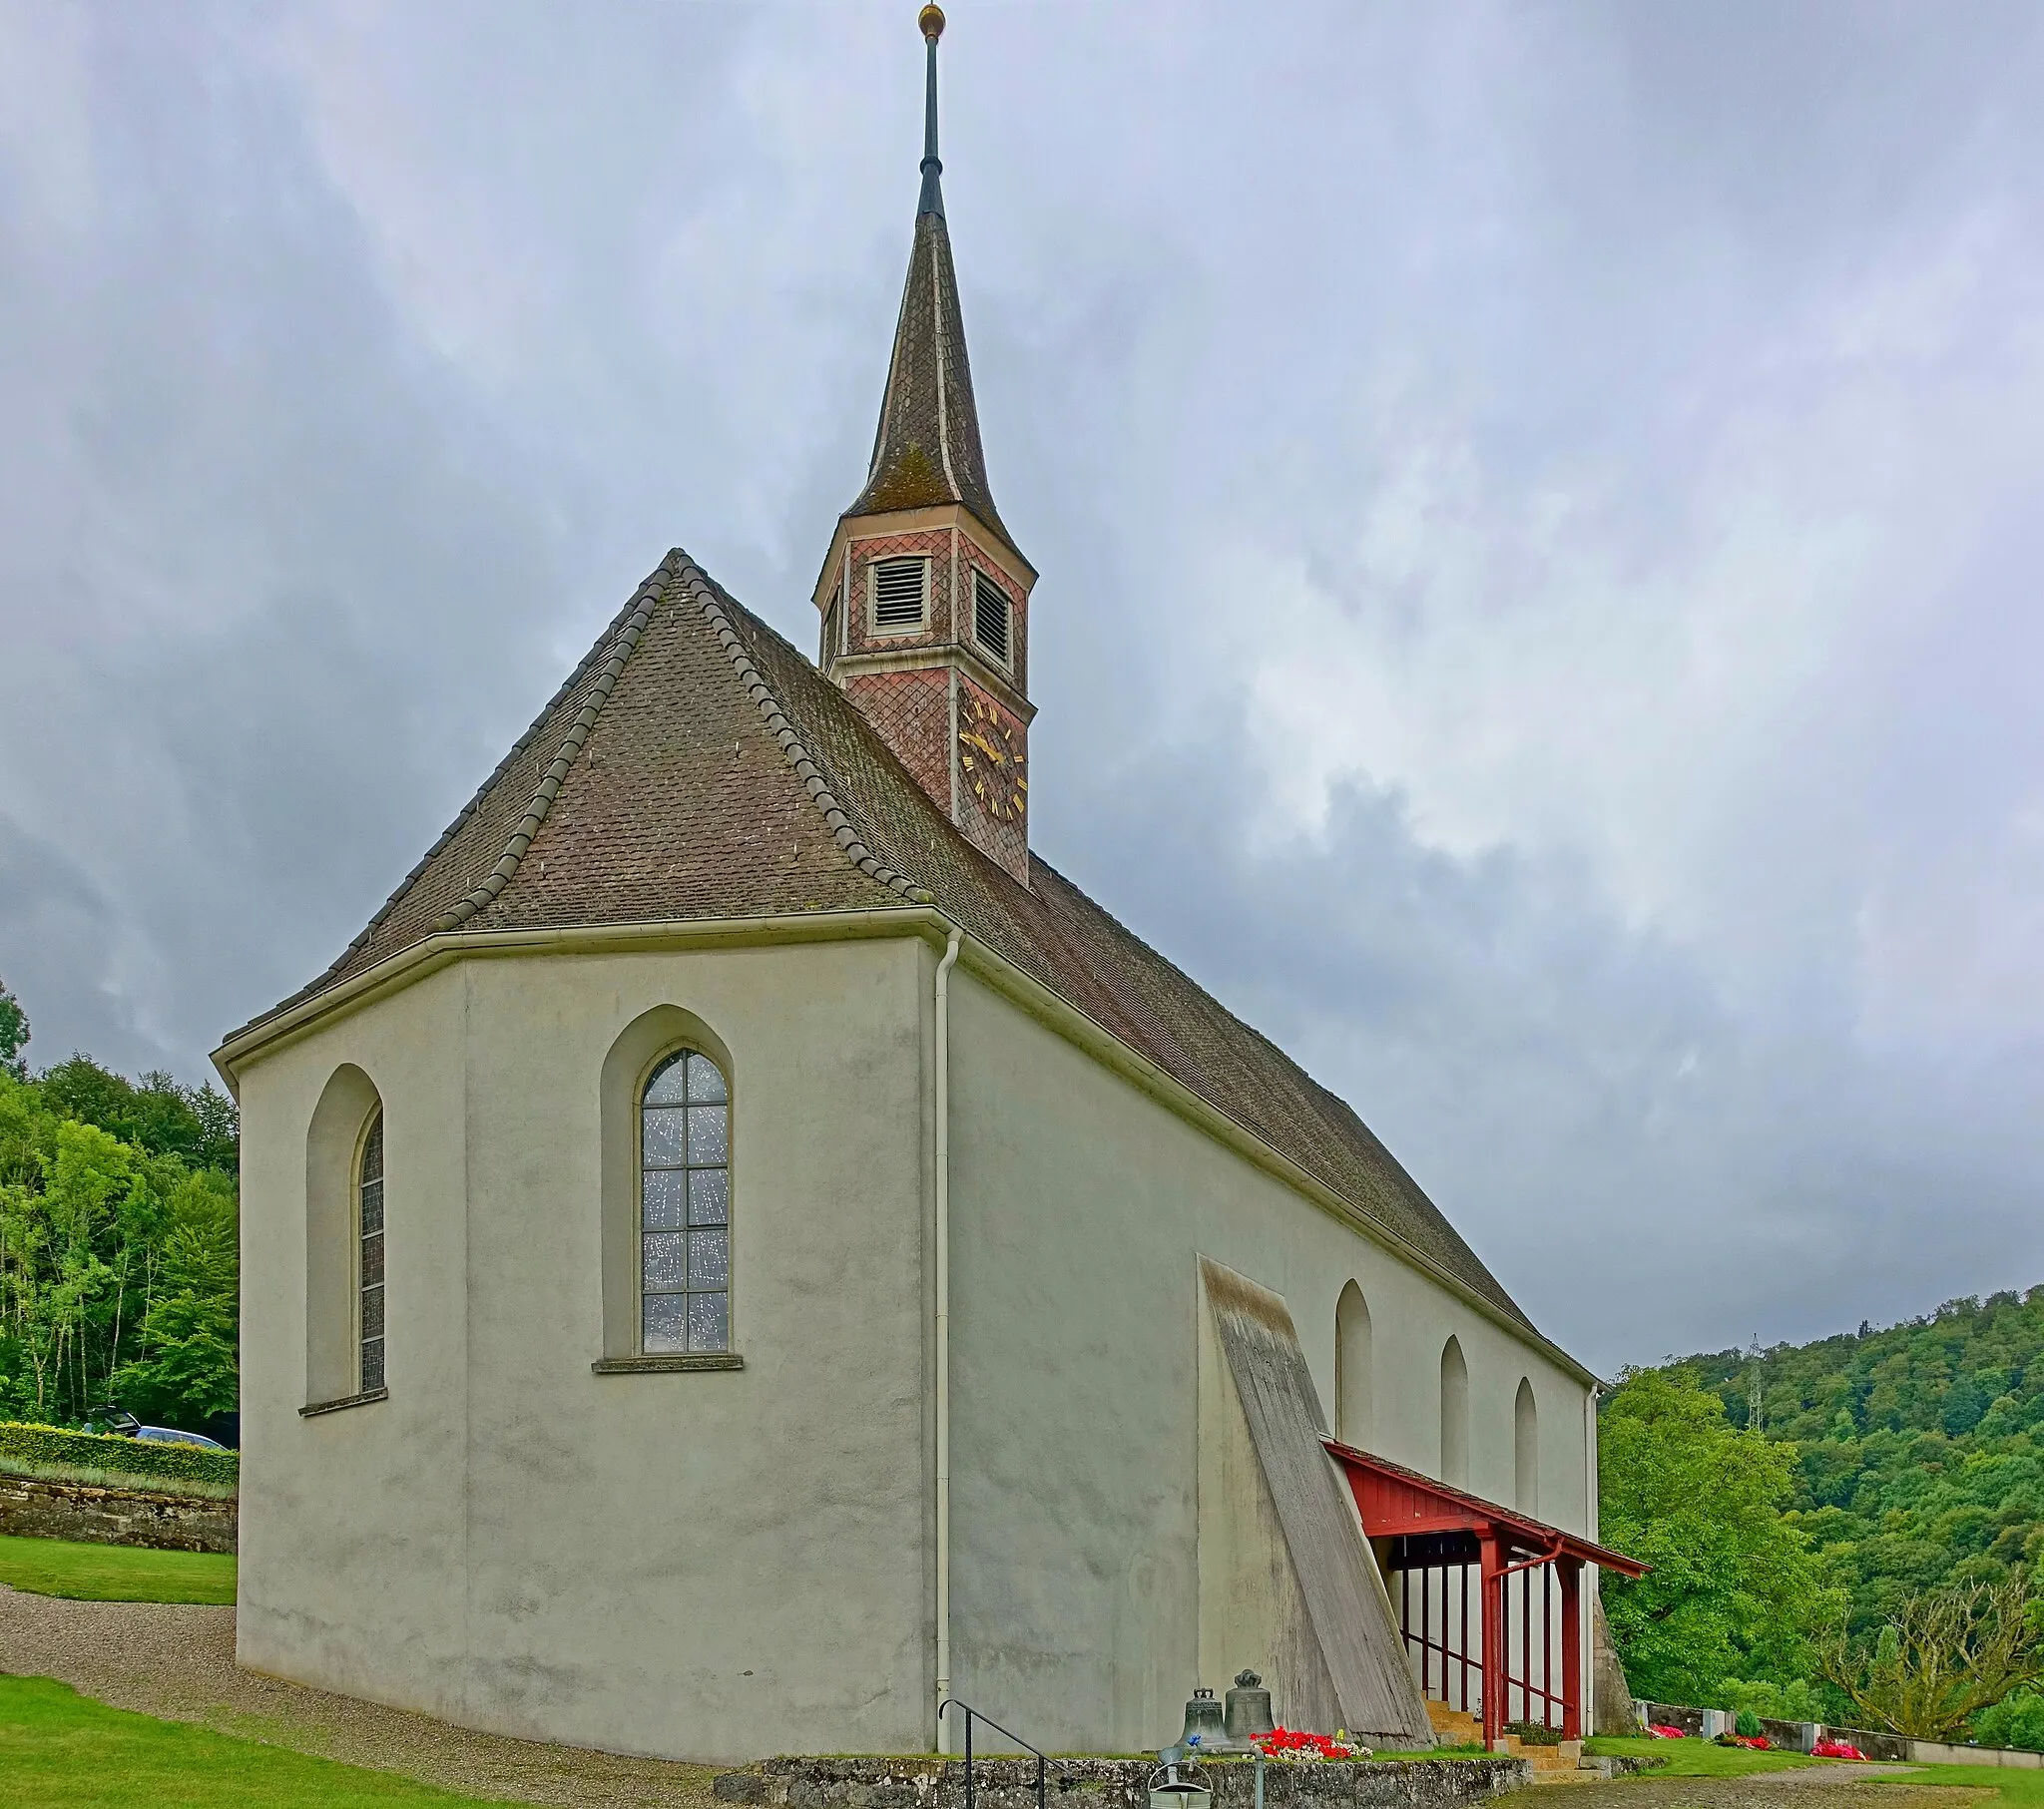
[[215, 6, 1625, 1762]]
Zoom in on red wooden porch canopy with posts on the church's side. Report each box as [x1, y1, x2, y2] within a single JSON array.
[[1320, 1439, 1648, 1745]]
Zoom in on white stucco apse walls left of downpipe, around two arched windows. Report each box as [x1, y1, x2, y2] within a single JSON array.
[[242, 940, 932, 1758]]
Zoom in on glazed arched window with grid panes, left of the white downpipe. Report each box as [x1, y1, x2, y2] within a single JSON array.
[[640, 1049, 732, 1353]]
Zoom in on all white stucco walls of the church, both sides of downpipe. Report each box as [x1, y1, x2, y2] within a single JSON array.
[[240, 936, 1588, 1760]]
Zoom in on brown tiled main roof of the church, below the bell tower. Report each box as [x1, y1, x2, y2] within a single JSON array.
[[238, 550, 1531, 1331]]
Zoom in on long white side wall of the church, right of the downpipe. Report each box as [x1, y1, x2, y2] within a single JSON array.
[[950, 977, 1588, 1750]]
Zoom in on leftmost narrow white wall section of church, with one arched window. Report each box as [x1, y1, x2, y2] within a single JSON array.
[[238, 973, 468, 1713]]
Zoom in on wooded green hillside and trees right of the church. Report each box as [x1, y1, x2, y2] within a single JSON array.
[[1601, 1288, 2044, 1745]]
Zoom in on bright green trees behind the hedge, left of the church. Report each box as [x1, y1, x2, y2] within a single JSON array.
[[0, 987, 240, 1435]]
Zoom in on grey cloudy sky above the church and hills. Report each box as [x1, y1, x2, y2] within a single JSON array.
[[0, 0, 2044, 1368]]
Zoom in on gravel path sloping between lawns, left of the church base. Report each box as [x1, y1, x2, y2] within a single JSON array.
[[0, 1584, 716, 1809]]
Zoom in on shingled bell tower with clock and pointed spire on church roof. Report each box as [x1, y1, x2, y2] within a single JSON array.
[[815, 6, 1036, 885]]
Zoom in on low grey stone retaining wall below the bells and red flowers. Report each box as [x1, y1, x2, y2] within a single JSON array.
[[716, 1756, 1533, 1809]]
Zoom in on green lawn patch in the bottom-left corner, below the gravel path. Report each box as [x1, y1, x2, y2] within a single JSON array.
[[0, 1676, 523, 1809]]
